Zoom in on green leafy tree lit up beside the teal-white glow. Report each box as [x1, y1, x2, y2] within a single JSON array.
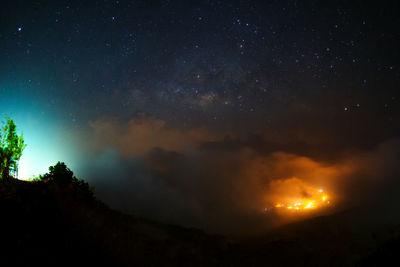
[[0, 119, 26, 179]]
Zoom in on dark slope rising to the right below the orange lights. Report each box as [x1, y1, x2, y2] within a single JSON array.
[[229, 207, 400, 266]]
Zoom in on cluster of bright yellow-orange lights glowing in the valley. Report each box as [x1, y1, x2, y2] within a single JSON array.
[[274, 189, 330, 211]]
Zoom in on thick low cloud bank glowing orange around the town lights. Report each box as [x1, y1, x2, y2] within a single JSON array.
[[77, 117, 400, 237]]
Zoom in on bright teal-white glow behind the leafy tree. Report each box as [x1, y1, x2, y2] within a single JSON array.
[[0, 88, 77, 180]]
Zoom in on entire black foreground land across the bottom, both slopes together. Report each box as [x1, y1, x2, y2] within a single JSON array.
[[0, 180, 400, 266]]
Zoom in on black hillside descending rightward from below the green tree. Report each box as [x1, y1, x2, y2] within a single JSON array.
[[0, 180, 221, 266]]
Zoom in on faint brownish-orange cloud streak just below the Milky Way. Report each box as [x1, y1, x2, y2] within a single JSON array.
[[90, 113, 215, 156]]
